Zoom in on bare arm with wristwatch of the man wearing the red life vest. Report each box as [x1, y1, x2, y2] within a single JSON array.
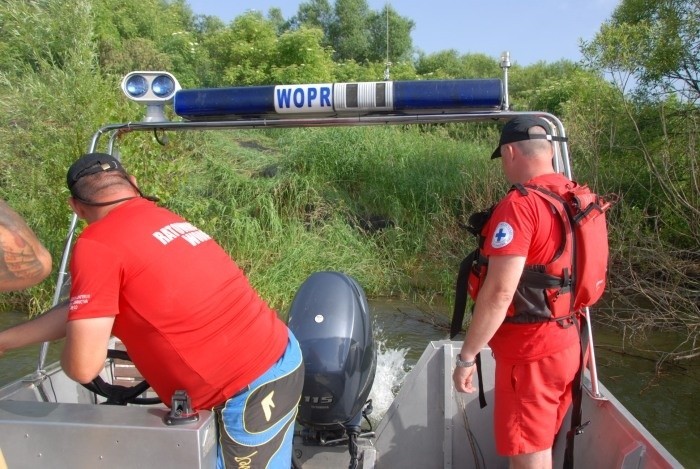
[[452, 256, 525, 392]]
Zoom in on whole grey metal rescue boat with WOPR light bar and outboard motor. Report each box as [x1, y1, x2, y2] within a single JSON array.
[[0, 61, 681, 469]]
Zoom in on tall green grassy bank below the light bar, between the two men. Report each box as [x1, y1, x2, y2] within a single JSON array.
[[162, 126, 505, 310]]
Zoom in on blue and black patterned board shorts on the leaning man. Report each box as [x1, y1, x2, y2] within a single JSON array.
[[214, 332, 304, 469]]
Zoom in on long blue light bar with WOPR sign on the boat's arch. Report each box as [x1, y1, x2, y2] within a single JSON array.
[[173, 79, 503, 121]]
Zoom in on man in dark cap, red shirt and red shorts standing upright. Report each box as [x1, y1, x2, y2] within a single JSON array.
[[453, 116, 580, 468]]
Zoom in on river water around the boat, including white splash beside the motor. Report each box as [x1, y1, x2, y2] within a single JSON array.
[[0, 300, 700, 468]]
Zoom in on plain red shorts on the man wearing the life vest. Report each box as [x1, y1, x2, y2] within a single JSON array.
[[494, 343, 581, 456]]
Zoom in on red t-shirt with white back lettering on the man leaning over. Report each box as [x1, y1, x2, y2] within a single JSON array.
[[68, 198, 288, 409]]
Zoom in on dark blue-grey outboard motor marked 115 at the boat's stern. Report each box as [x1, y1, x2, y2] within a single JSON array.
[[289, 272, 377, 467]]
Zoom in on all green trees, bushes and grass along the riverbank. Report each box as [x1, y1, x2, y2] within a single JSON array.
[[0, 0, 700, 358]]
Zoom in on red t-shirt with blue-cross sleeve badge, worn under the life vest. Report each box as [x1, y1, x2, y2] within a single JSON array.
[[482, 174, 579, 362]]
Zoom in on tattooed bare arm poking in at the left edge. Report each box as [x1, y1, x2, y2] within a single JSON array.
[[0, 200, 51, 292]]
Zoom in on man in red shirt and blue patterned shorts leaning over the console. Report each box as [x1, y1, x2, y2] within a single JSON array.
[[0, 153, 304, 468]]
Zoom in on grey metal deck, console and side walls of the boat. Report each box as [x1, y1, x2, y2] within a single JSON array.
[[0, 341, 682, 469]]
